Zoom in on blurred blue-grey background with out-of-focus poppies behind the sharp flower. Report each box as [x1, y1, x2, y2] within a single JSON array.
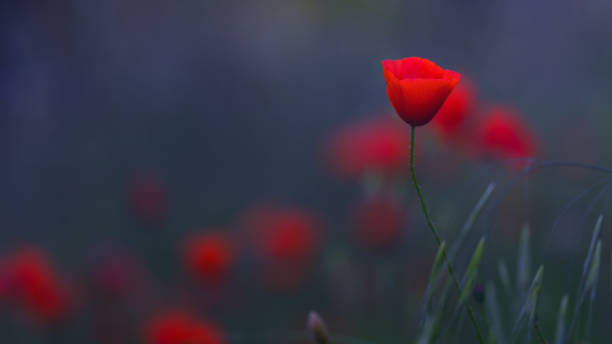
[[0, 0, 612, 344]]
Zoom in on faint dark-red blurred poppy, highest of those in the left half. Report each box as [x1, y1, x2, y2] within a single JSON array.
[[128, 175, 167, 223]]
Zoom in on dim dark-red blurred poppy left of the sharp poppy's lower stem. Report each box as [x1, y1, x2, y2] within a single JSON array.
[[353, 194, 405, 249]]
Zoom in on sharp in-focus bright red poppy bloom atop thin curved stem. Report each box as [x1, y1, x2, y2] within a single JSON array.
[[382, 57, 460, 127]]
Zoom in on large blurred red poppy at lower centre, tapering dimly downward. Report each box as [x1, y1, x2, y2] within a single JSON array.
[[246, 207, 321, 289]]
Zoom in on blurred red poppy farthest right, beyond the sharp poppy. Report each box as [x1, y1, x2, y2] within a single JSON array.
[[478, 106, 536, 159]]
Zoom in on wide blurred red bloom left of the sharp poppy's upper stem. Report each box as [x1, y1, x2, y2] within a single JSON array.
[[326, 118, 410, 177]]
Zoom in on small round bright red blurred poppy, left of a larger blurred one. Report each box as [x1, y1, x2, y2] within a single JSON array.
[[184, 233, 234, 283]]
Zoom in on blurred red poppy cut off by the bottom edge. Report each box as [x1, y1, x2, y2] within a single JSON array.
[[145, 311, 225, 344]]
